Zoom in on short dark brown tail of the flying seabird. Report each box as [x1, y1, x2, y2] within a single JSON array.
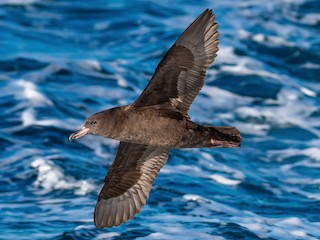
[[208, 127, 242, 148]]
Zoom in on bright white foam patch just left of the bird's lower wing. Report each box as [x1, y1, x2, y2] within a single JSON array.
[[31, 158, 97, 195]]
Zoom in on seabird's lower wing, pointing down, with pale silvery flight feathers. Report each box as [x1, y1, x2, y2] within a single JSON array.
[[94, 142, 169, 228]]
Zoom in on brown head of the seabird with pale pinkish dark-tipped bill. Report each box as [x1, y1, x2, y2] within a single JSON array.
[[69, 111, 106, 142]]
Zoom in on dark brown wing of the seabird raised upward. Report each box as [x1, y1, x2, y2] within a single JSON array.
[[133, 9, 219, 115]]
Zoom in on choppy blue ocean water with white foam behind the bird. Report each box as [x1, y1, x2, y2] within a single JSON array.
[[0, 0, 320, 240]]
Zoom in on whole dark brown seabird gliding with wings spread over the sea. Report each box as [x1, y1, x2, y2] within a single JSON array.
[[69, 9, 242, 228]]
